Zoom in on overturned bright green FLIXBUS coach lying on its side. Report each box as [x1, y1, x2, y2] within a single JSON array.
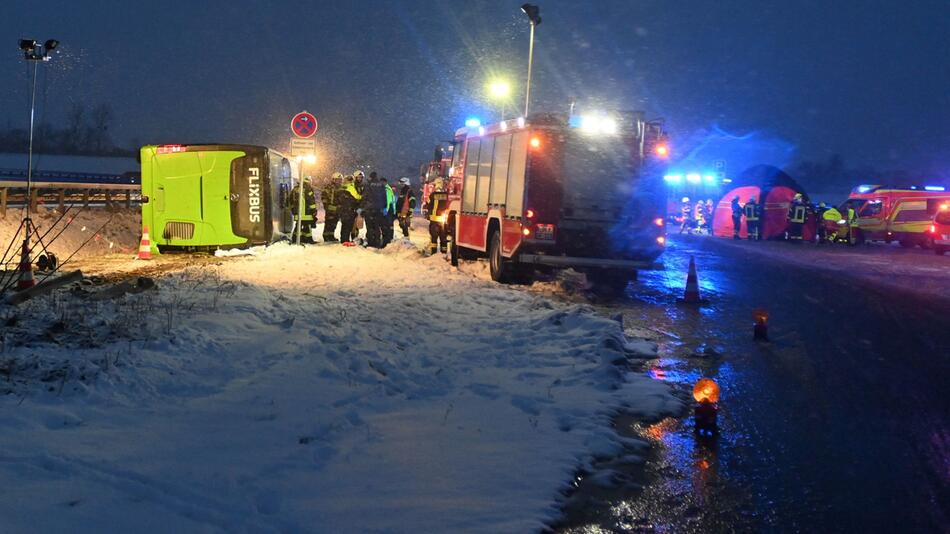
[[140, 145, 293, 253]]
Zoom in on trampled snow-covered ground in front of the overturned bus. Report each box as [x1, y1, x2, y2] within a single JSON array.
[[0, 241, 681, 532]]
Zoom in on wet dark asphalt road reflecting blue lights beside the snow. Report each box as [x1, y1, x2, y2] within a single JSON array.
[[575, 236, 950, 532]]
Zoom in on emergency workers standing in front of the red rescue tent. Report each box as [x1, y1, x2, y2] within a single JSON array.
[[731, 193, 857, 244]]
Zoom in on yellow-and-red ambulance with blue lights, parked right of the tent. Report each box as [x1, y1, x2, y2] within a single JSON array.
[[845, 185, 950, 248]]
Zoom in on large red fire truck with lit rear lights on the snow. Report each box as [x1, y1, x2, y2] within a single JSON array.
[[438, 112, 669, 288]]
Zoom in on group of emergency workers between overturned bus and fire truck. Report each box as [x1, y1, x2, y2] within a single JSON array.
[[289, 170, 416, 248]]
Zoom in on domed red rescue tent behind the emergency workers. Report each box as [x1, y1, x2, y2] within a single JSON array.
[[713, 165, 814, 239]]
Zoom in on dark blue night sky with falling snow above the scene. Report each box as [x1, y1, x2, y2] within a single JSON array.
[[0, 0, 950, 183]]
